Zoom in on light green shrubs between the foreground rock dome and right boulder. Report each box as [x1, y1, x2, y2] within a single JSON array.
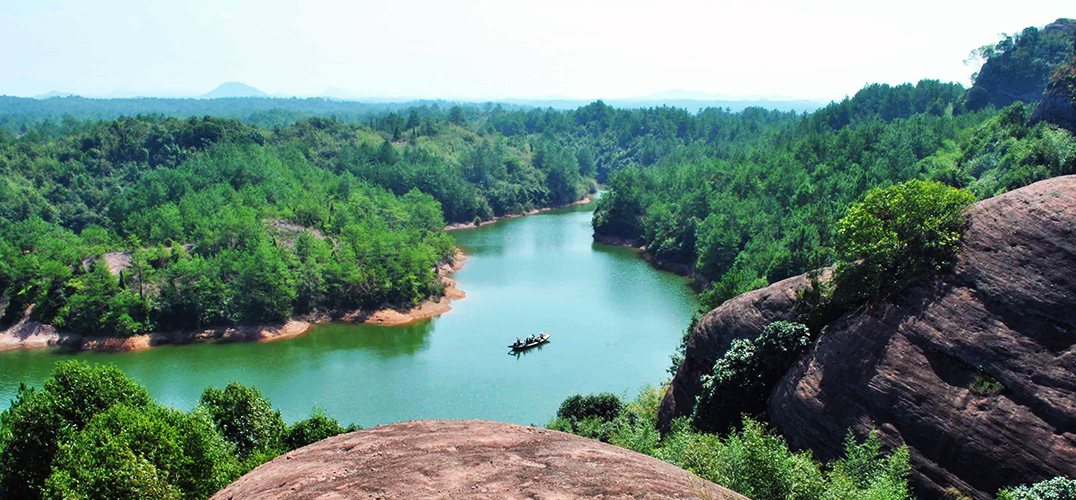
[[548, 387, 911, 500]]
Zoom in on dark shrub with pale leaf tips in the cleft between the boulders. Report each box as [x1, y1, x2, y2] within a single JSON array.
[[692, 322, 811, 432]]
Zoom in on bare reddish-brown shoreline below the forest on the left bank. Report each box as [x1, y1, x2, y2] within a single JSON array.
[[0, 247, 467, 353]]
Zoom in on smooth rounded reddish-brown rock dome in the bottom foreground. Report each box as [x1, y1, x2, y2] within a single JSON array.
[[213, 420, 745, 500]]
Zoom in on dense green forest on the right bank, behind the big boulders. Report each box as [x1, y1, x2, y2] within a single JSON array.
[[594, 76, 1076, 308]]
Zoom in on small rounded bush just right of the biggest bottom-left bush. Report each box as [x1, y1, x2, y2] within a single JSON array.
[[200, 382, 286, 460]]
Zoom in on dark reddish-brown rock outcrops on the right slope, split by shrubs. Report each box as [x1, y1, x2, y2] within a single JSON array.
[[662, 175, 1076, 499]]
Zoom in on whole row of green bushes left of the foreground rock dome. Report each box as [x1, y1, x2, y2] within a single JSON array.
[[0, 361, 360, 500]]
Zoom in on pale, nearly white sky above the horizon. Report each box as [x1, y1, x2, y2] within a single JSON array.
[[0, 0, 1076, 101]]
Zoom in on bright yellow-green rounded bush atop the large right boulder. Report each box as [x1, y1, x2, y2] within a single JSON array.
[[833, 181, 975, 304]]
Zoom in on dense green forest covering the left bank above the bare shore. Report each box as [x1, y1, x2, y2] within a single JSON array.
[[0, 111, 593, 335]]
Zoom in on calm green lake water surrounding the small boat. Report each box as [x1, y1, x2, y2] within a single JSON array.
[[0, 198, 697, 426]]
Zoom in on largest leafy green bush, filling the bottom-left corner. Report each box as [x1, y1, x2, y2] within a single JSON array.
[[0, 361, 240, 500]]
